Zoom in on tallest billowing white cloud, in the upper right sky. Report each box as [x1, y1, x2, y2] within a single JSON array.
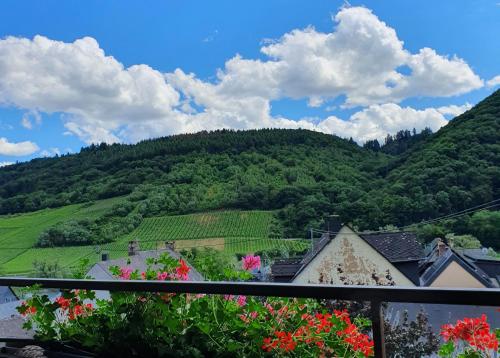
[[181, 7, 483, 106]]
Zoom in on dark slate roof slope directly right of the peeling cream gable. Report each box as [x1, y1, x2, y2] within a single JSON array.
[[358, 232, 424, 263]]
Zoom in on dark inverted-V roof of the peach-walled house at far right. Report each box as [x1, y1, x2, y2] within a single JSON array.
[[420, 240, 493, 288]]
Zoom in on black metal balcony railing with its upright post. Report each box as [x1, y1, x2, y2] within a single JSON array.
[[0, 277, 500, 357]]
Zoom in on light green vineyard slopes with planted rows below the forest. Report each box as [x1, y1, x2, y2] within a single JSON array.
[[0, 204, 308, 275]]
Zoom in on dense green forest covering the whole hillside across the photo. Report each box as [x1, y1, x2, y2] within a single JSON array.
[[0, 91, 500, 247]]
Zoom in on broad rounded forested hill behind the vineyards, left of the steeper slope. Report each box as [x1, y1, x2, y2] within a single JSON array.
[[0, 129, 388, 228]]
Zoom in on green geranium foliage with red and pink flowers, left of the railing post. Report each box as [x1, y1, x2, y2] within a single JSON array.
[[18, 256, 373, 357]]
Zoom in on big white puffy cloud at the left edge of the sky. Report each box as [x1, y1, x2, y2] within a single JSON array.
[[0, 36, 179, 142]]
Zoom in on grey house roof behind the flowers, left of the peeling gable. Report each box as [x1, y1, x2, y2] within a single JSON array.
[[87, 249, 204, 281]]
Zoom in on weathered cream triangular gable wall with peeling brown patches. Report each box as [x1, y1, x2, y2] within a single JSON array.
[[293, 226, 415, 286]]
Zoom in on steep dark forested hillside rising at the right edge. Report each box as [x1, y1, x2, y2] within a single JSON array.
[[360, 91, 500, 227]]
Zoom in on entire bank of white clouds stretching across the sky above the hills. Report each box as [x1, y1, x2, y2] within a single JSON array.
[[0, 7, 483, 143]]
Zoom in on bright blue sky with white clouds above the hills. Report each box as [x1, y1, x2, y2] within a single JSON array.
[[0, 0, 500, 163]]
